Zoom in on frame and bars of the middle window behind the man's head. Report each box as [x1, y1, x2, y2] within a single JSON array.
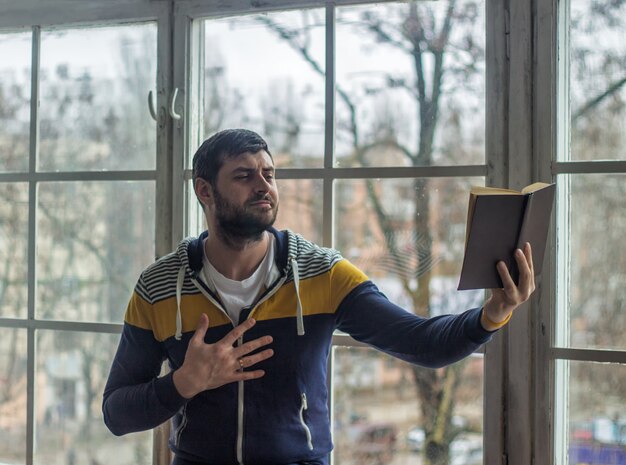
[[172, 0, 516, 465]]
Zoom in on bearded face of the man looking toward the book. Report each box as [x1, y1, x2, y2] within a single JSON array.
[[210, 150, 278, 239]]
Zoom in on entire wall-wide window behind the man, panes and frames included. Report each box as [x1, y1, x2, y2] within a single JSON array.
[[0, 0, 626, 465]]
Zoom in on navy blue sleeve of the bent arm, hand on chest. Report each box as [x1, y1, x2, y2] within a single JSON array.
[[102, 323, 187, 436]]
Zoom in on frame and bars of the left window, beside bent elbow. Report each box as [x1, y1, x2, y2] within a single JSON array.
[[0, 0, 172, 465]]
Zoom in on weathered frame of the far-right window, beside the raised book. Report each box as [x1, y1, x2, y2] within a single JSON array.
[[534, 0, 626, 464]]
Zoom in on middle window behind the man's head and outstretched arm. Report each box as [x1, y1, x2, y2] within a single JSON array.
[[186, 1, 487, 465]]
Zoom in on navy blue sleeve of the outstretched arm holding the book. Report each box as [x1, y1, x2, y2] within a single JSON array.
[[337, 281, 493, 368]]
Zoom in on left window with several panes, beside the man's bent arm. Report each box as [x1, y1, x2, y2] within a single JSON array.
[[0, 23, 156, 465]]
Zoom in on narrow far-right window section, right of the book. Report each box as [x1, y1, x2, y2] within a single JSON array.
[[553, 0, 626, 465]]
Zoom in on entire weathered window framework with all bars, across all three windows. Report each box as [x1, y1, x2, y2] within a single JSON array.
[[7, 0, 612, 465]]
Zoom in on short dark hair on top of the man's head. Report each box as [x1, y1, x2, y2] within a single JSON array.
[[192, 129, 272, 186]]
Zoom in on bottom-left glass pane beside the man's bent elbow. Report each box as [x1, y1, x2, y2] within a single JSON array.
[[34, 331, 152, 465]]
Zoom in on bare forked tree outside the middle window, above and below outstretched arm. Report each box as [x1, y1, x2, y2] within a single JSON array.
[[249, 0, 484, 465]]
